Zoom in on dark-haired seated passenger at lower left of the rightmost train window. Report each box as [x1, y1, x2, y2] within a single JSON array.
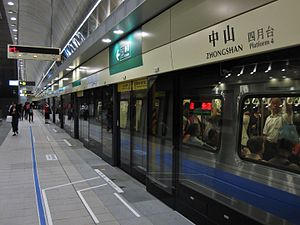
[[245, 136, 264, 160]]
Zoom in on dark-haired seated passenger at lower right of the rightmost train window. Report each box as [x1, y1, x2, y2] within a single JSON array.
[[268, 139, 299, 169]]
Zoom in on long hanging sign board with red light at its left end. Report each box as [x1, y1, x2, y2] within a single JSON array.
[[7, 44, 61, 61]]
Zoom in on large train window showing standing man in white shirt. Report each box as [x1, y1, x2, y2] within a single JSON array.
[[240, 96, 300, 170]]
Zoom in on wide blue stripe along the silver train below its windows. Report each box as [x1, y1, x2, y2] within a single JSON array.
[[157, 153, 300, 224]]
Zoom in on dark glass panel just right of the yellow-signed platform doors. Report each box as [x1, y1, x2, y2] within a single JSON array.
[[147, 76, 176, 206]]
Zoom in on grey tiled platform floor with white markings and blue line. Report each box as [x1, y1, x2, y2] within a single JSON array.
[[0, 112, 193, 225]]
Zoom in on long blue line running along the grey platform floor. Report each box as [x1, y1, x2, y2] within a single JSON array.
[[30, 127, 47, 225]]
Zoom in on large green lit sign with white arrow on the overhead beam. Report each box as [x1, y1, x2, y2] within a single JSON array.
[[109, 30, 143, 75]]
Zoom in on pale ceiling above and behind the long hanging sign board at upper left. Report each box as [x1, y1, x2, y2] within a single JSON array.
[[2, 0, 96, 82]]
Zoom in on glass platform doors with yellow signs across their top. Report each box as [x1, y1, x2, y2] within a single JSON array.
[[119, 79, 147, 183]]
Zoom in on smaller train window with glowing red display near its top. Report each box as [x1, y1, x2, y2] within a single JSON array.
[[182, 96, 222, 151]]
